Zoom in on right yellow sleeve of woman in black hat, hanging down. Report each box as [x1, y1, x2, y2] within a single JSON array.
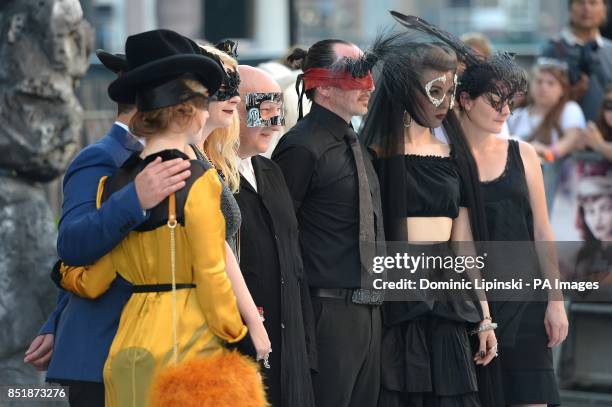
[[185, 169, 247, 343]]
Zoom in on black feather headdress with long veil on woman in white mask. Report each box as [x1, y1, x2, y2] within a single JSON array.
[[360, 12, 487, 240]]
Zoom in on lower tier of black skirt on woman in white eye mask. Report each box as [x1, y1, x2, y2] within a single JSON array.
[[379, 316, 481, 407]]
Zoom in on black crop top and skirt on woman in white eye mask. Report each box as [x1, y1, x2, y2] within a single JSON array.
[[374, 155, 482, 407]]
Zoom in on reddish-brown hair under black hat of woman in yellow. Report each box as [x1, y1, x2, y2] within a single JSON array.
[[129, 79, 208, 138]]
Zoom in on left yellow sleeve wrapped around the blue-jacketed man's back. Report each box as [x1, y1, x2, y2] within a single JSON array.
[[60, 176, 116, 298]]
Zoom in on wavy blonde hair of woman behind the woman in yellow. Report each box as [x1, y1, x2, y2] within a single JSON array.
[[200, 45, 240, 193]]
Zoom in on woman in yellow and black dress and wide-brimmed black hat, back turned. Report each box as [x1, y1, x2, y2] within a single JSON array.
[[56, 30, 258, 406]]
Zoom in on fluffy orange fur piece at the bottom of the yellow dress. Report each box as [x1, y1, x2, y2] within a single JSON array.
[[150, 351, 269, 407]]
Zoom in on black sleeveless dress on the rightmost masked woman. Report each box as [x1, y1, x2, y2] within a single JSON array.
[[481, 140, 560, 405]]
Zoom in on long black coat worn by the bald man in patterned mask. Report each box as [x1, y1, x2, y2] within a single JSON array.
[[236, 156, 317, 407]]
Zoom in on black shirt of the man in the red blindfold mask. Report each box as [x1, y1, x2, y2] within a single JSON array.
[[272, 103, 361, 288]]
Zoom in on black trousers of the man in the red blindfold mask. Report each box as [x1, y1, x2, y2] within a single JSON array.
[[312, 297, 382, 407]]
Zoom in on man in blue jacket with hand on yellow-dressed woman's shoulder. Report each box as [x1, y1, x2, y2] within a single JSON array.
[[25, 50, 190, 407]]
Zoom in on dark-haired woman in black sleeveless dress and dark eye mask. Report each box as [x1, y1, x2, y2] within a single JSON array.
[[457, 54, 568, 407]]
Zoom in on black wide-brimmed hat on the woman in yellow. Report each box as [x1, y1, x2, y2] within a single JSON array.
[[108, 30, 225, 110]]
